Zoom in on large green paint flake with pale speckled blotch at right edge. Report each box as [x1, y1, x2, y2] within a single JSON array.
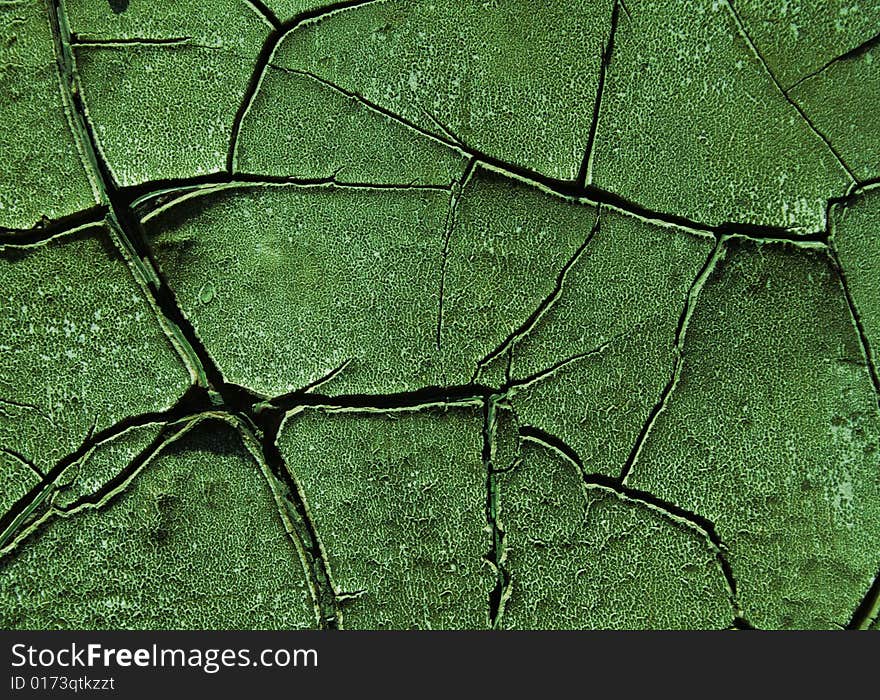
[[627, 239, 880, 628]]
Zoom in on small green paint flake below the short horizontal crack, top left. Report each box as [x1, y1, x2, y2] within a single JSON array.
[[76, 44, 258, 186]]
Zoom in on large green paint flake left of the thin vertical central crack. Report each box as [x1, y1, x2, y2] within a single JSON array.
[[146, 186, 450, 395]]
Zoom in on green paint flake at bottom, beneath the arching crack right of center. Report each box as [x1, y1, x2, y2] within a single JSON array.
[[498, 446, 733, 629]]
